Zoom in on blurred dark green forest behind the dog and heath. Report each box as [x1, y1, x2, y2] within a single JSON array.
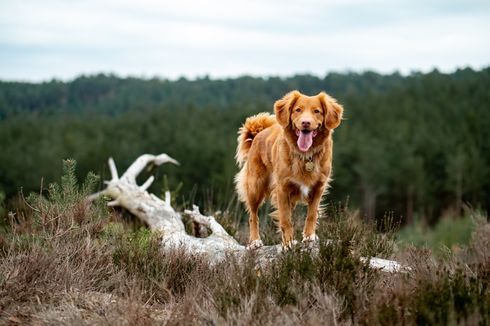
[[0, 68, 490, 222]]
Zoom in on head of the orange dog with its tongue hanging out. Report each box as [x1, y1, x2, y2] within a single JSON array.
[[274, 91, 343, 152]]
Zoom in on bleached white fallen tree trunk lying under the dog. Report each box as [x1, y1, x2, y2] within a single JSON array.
[[89, 154, 405, 272]]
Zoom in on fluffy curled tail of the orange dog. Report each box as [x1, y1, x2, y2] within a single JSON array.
[[235, 113, 276, 167]]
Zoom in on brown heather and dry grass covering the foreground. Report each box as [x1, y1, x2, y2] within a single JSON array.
[[0, 162, 490, 325]]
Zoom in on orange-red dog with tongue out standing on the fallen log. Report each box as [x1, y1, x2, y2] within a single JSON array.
[[235, 91, 343, 249]]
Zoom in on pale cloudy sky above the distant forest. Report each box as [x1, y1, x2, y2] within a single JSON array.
[[0, 0, 490, 81]]
